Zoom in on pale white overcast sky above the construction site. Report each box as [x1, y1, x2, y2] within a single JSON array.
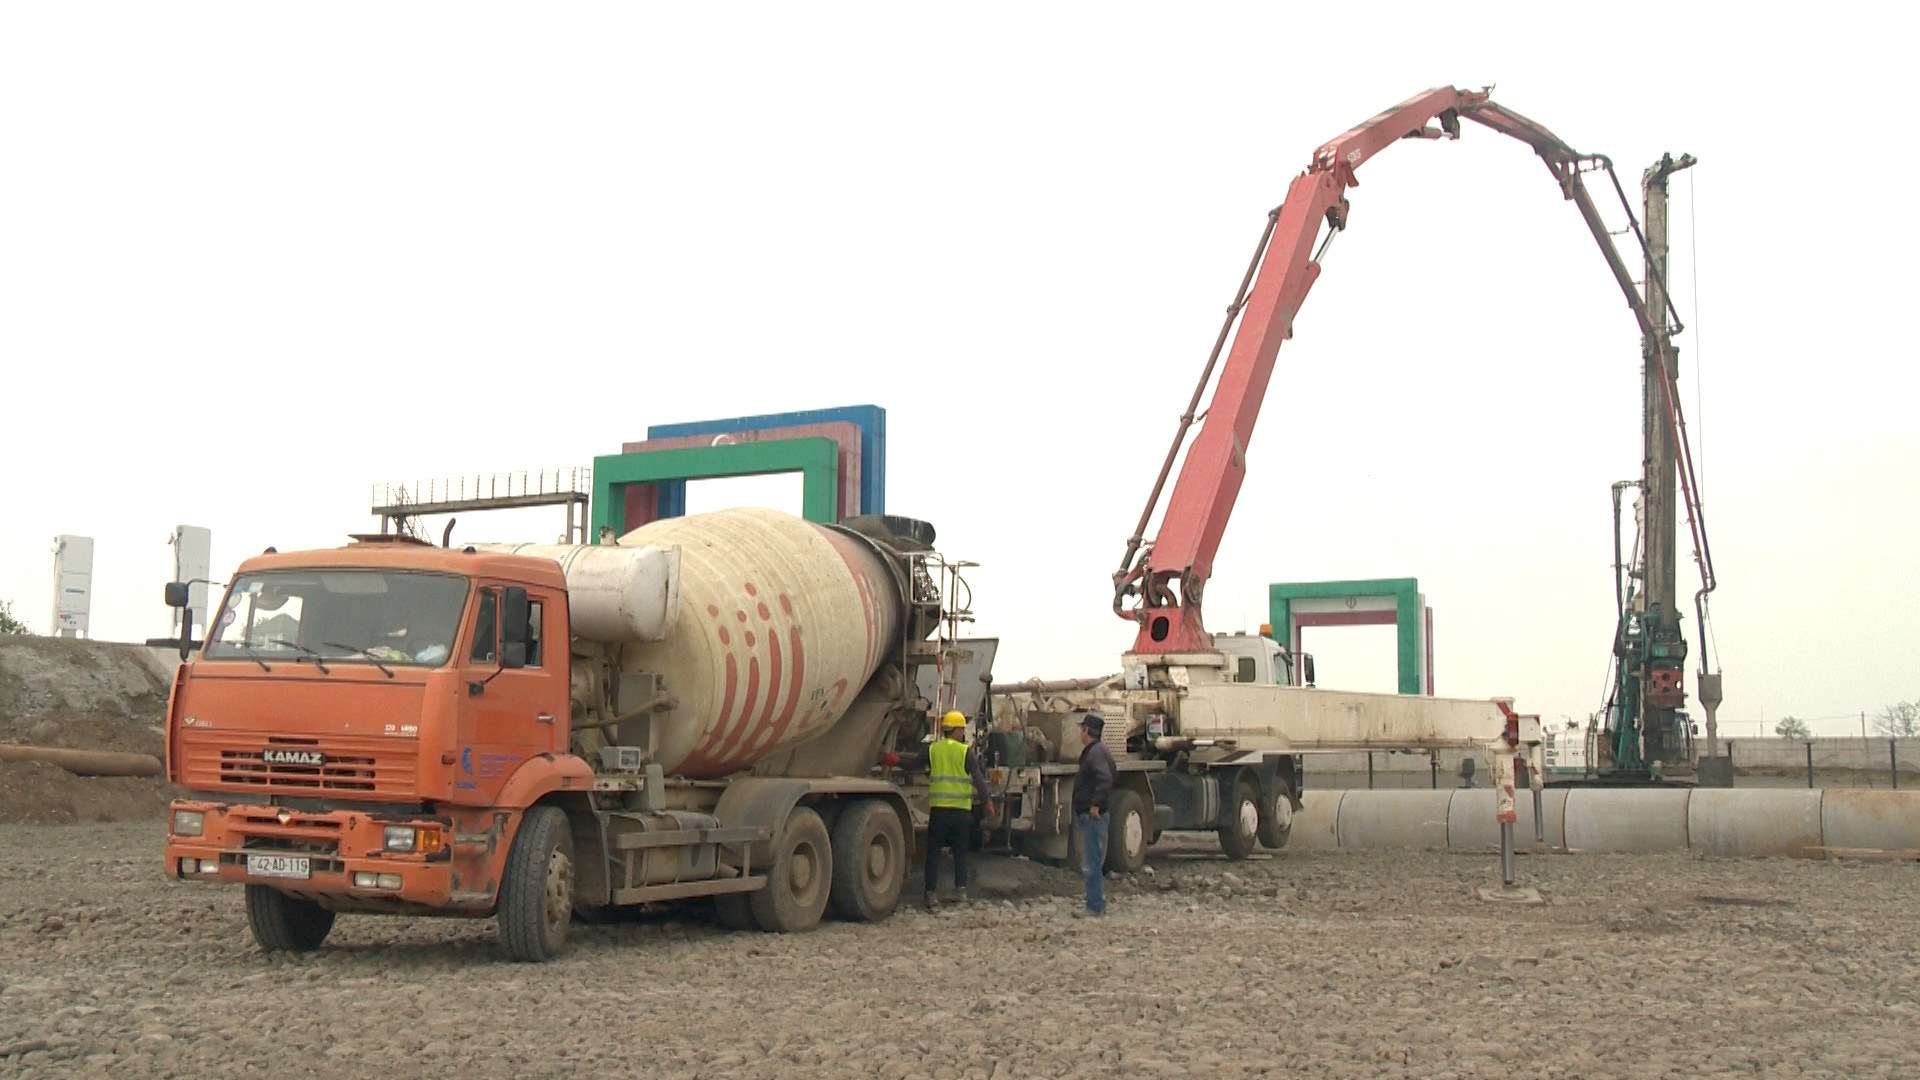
[[0, 4, 1920, 736]]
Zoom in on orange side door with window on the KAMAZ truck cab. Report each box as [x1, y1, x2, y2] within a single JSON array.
[[453, 584, 568, 799]]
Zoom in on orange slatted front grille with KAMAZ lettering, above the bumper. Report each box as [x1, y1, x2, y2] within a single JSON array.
[[182, 732, 415, 796]]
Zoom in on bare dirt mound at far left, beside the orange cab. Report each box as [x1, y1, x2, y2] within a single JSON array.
[[0, 636, 171, 822]]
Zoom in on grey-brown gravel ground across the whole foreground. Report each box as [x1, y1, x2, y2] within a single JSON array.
[[0, 822, 1920, 1080]]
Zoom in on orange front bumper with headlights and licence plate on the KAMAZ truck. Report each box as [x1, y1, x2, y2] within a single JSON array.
[[165, 799, 497, 909]]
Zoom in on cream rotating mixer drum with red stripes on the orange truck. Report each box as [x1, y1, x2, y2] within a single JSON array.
[[618, 507, 906, 778]]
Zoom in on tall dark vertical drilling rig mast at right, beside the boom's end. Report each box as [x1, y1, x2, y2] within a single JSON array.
[[1638, 154, 1718, 769]]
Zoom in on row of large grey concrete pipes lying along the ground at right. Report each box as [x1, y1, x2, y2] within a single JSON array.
[[1290, 788, 1920, 859]]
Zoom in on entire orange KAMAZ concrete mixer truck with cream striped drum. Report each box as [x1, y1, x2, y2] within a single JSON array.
[[167, 509, 956, 961]]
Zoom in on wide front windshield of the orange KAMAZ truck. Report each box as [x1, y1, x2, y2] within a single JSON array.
[[205, 571, 468, 667]]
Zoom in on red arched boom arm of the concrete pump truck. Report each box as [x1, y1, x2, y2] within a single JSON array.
[[1114, 86, 1697, 655]]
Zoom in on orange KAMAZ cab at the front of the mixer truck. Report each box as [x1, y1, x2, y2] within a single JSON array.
[[165, 536, 586, 947]]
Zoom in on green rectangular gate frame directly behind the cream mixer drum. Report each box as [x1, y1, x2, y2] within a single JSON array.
[[591, 438, 839, 544]]
